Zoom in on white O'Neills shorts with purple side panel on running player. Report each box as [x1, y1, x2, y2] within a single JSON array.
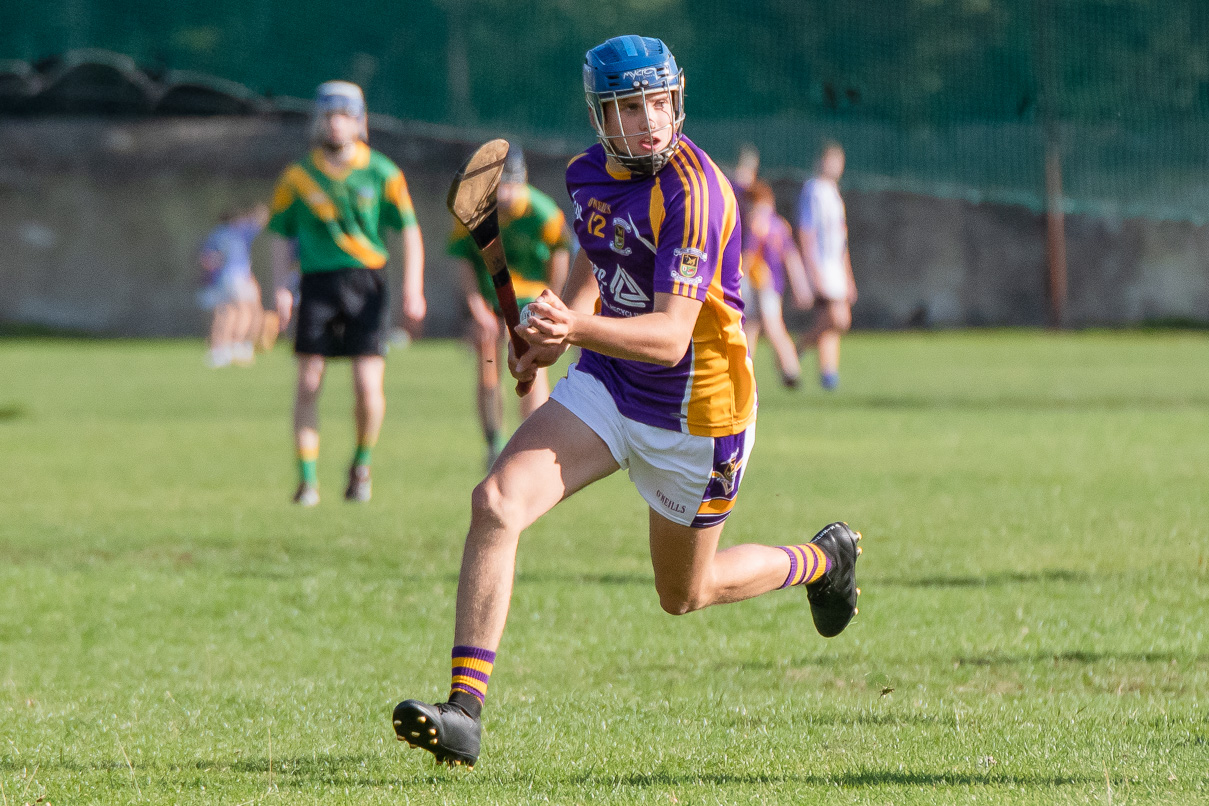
[[550, 364, 756, 528]]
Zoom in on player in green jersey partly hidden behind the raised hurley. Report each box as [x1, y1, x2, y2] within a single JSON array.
[[447, 145, 569, 468]]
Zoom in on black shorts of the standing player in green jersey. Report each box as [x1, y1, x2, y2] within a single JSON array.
[[294, 268, 389, 358]]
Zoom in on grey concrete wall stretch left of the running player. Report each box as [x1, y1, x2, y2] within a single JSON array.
[[0, 118, 566, 336]]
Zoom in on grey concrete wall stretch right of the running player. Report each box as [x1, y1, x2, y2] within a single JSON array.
[[776, 182, 1209, 327]]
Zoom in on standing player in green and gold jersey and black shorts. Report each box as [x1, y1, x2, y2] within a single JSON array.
[[268, 81, 426, 506]]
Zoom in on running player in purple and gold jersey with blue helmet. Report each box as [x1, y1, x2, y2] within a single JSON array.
[[394, 36, 860, 765]]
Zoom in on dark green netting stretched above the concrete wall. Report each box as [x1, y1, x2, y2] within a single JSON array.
[[7, 0, 1209, 222]]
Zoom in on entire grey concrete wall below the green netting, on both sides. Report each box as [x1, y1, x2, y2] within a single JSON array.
[[0, 118, 1209, 336]]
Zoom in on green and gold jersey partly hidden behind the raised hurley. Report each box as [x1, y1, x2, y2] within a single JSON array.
[[446, 185, 569, 311]]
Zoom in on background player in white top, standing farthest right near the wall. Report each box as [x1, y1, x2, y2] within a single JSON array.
[[798, 141, 856, 389]]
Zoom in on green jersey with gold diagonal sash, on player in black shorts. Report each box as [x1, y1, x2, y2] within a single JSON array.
[[268, 143, 416, 274]]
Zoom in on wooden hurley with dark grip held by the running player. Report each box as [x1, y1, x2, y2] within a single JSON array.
[[445, 140, 533, 398]]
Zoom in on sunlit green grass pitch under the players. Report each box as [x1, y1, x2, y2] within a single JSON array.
[[0, 332, 1209, 806]]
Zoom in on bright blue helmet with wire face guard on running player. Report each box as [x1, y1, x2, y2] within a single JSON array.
[[584, 35, 684, 174]]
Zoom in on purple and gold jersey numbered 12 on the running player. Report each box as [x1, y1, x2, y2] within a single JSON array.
[[567, 138, 756, 436]]
